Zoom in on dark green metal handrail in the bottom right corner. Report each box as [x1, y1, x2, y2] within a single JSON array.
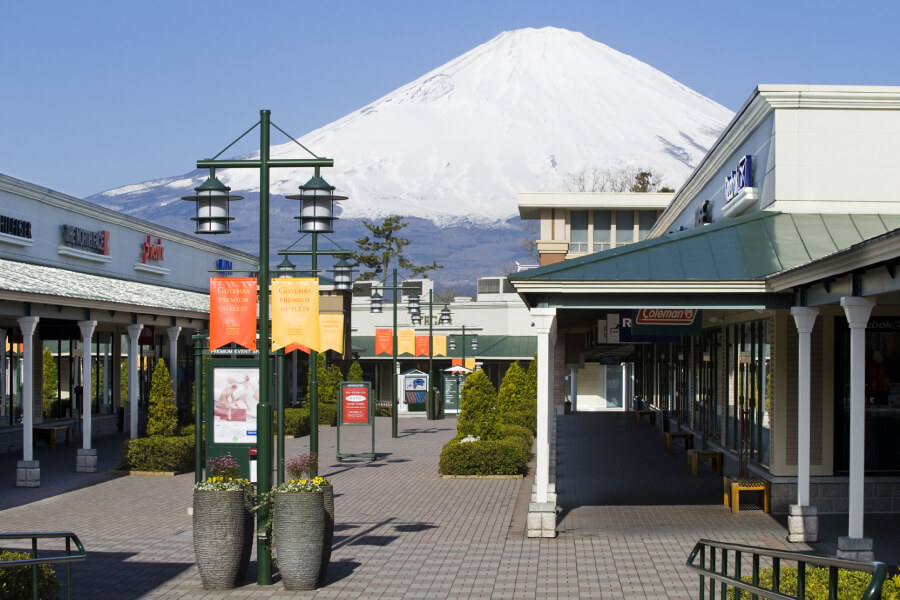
[[685, 539, 887, 600]]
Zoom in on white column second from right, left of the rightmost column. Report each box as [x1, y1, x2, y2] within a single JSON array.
[[791, 306, 819, 506]]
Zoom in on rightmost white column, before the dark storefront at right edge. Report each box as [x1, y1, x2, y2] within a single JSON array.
[[841, 296, 875, 539]]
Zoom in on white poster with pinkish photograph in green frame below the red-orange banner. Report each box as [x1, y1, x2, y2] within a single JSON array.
[[213, 367, 259, 444]]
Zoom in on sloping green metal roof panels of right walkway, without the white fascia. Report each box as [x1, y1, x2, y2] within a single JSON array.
[[509, 211, 900, 283]]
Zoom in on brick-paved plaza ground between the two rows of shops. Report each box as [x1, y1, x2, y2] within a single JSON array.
[[0, 413, 896, 600]]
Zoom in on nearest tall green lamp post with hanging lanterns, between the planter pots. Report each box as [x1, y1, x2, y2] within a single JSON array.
[[183, 110, 334, 585]]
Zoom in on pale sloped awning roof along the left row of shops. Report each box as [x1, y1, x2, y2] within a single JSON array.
[[0, 259, 209, 316]]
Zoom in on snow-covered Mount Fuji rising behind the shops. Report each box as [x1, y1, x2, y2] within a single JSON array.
[[87, 27, 733, 290]]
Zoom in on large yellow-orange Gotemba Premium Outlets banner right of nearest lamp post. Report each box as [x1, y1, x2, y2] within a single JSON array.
[[272, 277, 319, 350]]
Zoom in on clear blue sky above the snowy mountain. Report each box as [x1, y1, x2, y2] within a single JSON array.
[[0, 0, 900, 197]]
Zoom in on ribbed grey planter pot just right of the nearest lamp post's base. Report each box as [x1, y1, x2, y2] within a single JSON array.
[[272, 492, 326, 591]]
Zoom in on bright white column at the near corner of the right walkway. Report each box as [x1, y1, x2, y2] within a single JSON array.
[[531, 308, 556, 503]]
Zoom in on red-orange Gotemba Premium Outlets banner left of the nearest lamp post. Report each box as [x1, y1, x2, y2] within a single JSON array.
[[209, 277, 256, 350]]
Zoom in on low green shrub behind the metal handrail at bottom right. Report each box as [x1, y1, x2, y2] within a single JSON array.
[[728, 567, 900, 600]]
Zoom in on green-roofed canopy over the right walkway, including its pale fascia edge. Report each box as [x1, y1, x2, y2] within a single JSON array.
[[509, 211, 900, 308]]
